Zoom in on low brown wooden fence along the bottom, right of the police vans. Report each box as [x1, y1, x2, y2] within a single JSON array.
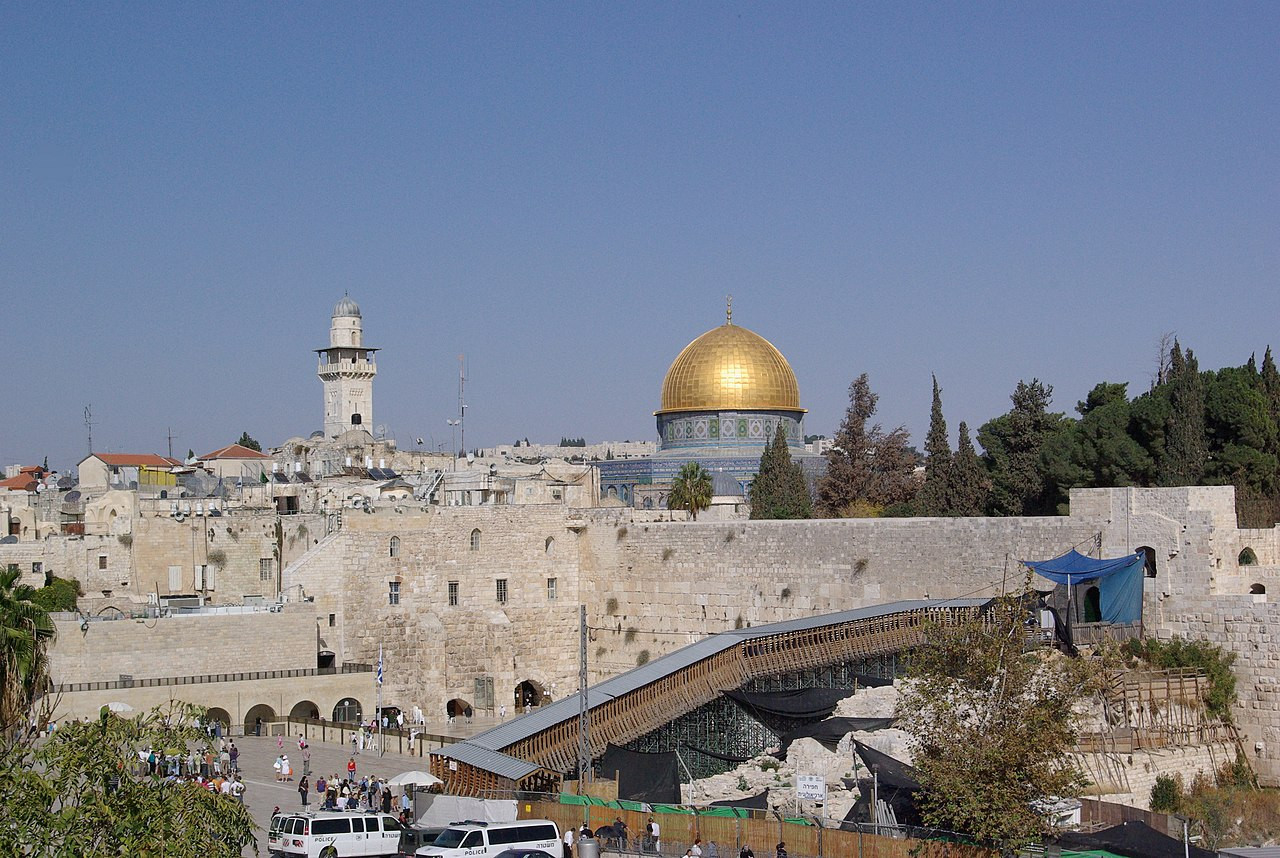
[[517, 800, 998, 858]]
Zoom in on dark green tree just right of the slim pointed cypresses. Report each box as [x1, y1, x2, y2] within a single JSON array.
[[978, 378, 1069, 515]]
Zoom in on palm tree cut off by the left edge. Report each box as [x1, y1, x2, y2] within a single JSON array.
[[0, 565, 56, 733]]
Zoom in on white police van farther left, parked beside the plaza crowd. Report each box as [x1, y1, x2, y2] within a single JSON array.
[[266, 811, 403, 858]]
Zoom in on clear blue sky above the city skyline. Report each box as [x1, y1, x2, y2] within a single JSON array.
[[0, 3, 1280, 467]]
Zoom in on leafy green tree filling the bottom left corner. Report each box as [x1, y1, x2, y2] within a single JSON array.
[[0, 704, 256, 858]]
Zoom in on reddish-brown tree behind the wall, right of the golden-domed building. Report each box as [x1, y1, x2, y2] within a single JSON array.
[[818, 373, 919, 516]]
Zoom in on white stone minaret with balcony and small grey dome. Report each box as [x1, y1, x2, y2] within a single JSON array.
[[316, 296, 378, 438]]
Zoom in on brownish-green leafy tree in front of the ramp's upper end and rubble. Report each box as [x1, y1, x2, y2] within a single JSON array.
[[897, 597, 1091, 850]]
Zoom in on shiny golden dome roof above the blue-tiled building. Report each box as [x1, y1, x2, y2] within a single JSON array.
[[654, 323, 804, 414]]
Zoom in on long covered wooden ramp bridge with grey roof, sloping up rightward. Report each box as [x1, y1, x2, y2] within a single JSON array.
[[430, 599, 988, 795]]
